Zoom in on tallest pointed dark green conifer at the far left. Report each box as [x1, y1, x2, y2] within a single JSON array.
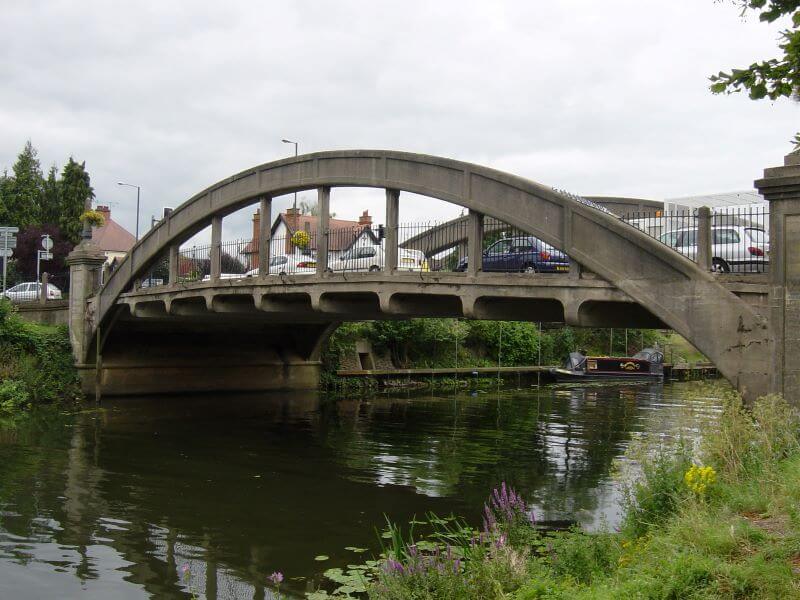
[[3, 140, 44, 229]]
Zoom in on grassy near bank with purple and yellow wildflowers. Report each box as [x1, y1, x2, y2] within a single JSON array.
[[314, 385, 800, 600]]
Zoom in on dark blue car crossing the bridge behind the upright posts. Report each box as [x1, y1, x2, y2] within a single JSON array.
[[456, 235, 569, 273]]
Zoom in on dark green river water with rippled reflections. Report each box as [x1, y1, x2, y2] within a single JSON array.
[[0, 384, 718, 600]]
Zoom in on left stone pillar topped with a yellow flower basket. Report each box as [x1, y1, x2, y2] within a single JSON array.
[[66, 239, 106, 369]]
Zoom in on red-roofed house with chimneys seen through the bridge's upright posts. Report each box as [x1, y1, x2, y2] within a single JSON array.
[[242, 208, 380, 269]]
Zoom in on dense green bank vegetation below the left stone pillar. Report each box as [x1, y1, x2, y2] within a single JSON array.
[[0, 299, 80, 418]]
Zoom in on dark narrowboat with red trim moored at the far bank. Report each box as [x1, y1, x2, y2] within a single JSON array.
[[550, 348, 664, 383]]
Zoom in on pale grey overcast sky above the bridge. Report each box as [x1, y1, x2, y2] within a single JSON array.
[[0, 0, 800, 238]]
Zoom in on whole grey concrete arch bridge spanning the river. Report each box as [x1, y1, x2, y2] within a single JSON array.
[[69, 150, 772, 395]]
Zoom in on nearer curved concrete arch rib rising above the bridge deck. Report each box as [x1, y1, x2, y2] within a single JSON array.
[[95, 150, 771, 396]]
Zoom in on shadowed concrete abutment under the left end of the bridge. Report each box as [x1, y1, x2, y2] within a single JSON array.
[[82, 314, 331, 396]]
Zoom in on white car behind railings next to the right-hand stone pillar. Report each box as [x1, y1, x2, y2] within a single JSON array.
[[658, 225, 769, 273]]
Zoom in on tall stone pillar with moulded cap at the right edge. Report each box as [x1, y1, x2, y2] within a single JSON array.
[[755, 152, 800, 406]]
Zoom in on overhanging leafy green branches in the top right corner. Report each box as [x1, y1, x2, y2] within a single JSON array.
[[711, 0, 800, 149]]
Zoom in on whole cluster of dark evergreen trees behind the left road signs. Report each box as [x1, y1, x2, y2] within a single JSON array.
[[0, 140, 95, 283]]
